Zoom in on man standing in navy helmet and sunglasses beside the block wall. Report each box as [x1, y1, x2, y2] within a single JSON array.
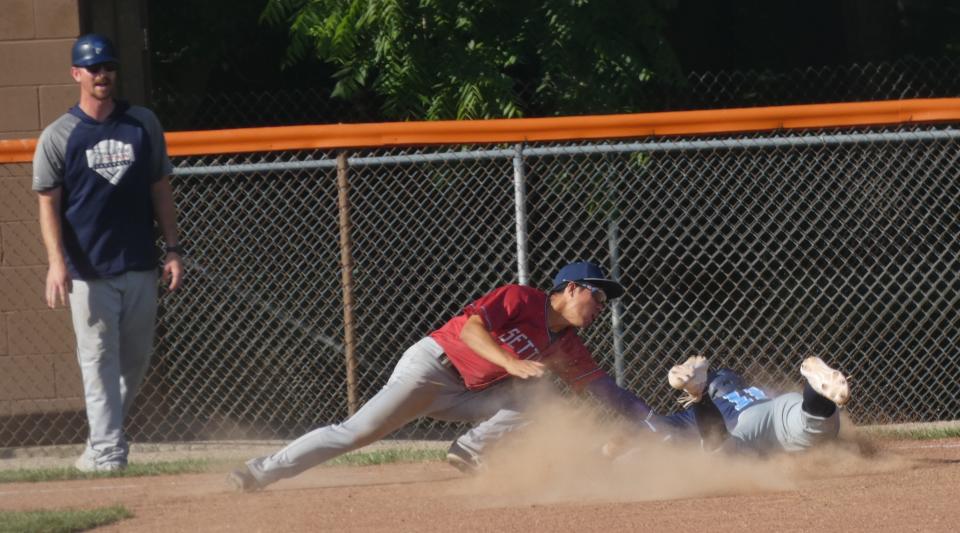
[[33, 34, 183, 472]]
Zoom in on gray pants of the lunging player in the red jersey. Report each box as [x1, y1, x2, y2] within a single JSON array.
[[247, 337, 542, 484]]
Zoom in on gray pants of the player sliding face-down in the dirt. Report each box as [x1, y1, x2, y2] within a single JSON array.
[[730, 392, 840, 452]]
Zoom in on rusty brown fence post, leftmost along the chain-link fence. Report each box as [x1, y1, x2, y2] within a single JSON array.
[[337, 152, 357, 415]]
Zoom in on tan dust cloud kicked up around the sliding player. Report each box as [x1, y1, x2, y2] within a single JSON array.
[[457, 392, 911, 507]]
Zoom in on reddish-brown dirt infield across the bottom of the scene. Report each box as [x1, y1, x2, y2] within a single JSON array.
[[0, 432, 960, 533]]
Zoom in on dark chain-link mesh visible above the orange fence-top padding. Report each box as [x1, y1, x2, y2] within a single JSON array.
[[153, 56, 960, 131]]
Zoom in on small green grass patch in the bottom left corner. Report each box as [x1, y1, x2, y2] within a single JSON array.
[[0, 505, 133, 533]]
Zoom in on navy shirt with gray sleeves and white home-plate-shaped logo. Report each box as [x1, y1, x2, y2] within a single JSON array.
[[33, 101, 173, 280]]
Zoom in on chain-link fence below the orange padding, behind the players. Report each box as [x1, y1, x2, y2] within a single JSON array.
[[2, 122, 960, 443]]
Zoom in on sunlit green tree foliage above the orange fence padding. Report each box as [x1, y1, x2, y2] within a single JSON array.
[[261, 0, 679, 119]]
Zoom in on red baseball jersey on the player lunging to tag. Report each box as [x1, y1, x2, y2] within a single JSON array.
[[430, 285, 606, 391]]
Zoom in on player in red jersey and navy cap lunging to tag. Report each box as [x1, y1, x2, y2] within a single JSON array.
[[228, 262, 650, 491]]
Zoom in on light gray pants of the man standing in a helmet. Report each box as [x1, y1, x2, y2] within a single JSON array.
[[70, 270, 157, 465]]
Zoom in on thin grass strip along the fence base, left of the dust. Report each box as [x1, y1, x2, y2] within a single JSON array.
[[0, 448, 446, 483]]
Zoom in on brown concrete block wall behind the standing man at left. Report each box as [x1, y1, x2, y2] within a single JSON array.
[[0, 0, 83, 417]]
